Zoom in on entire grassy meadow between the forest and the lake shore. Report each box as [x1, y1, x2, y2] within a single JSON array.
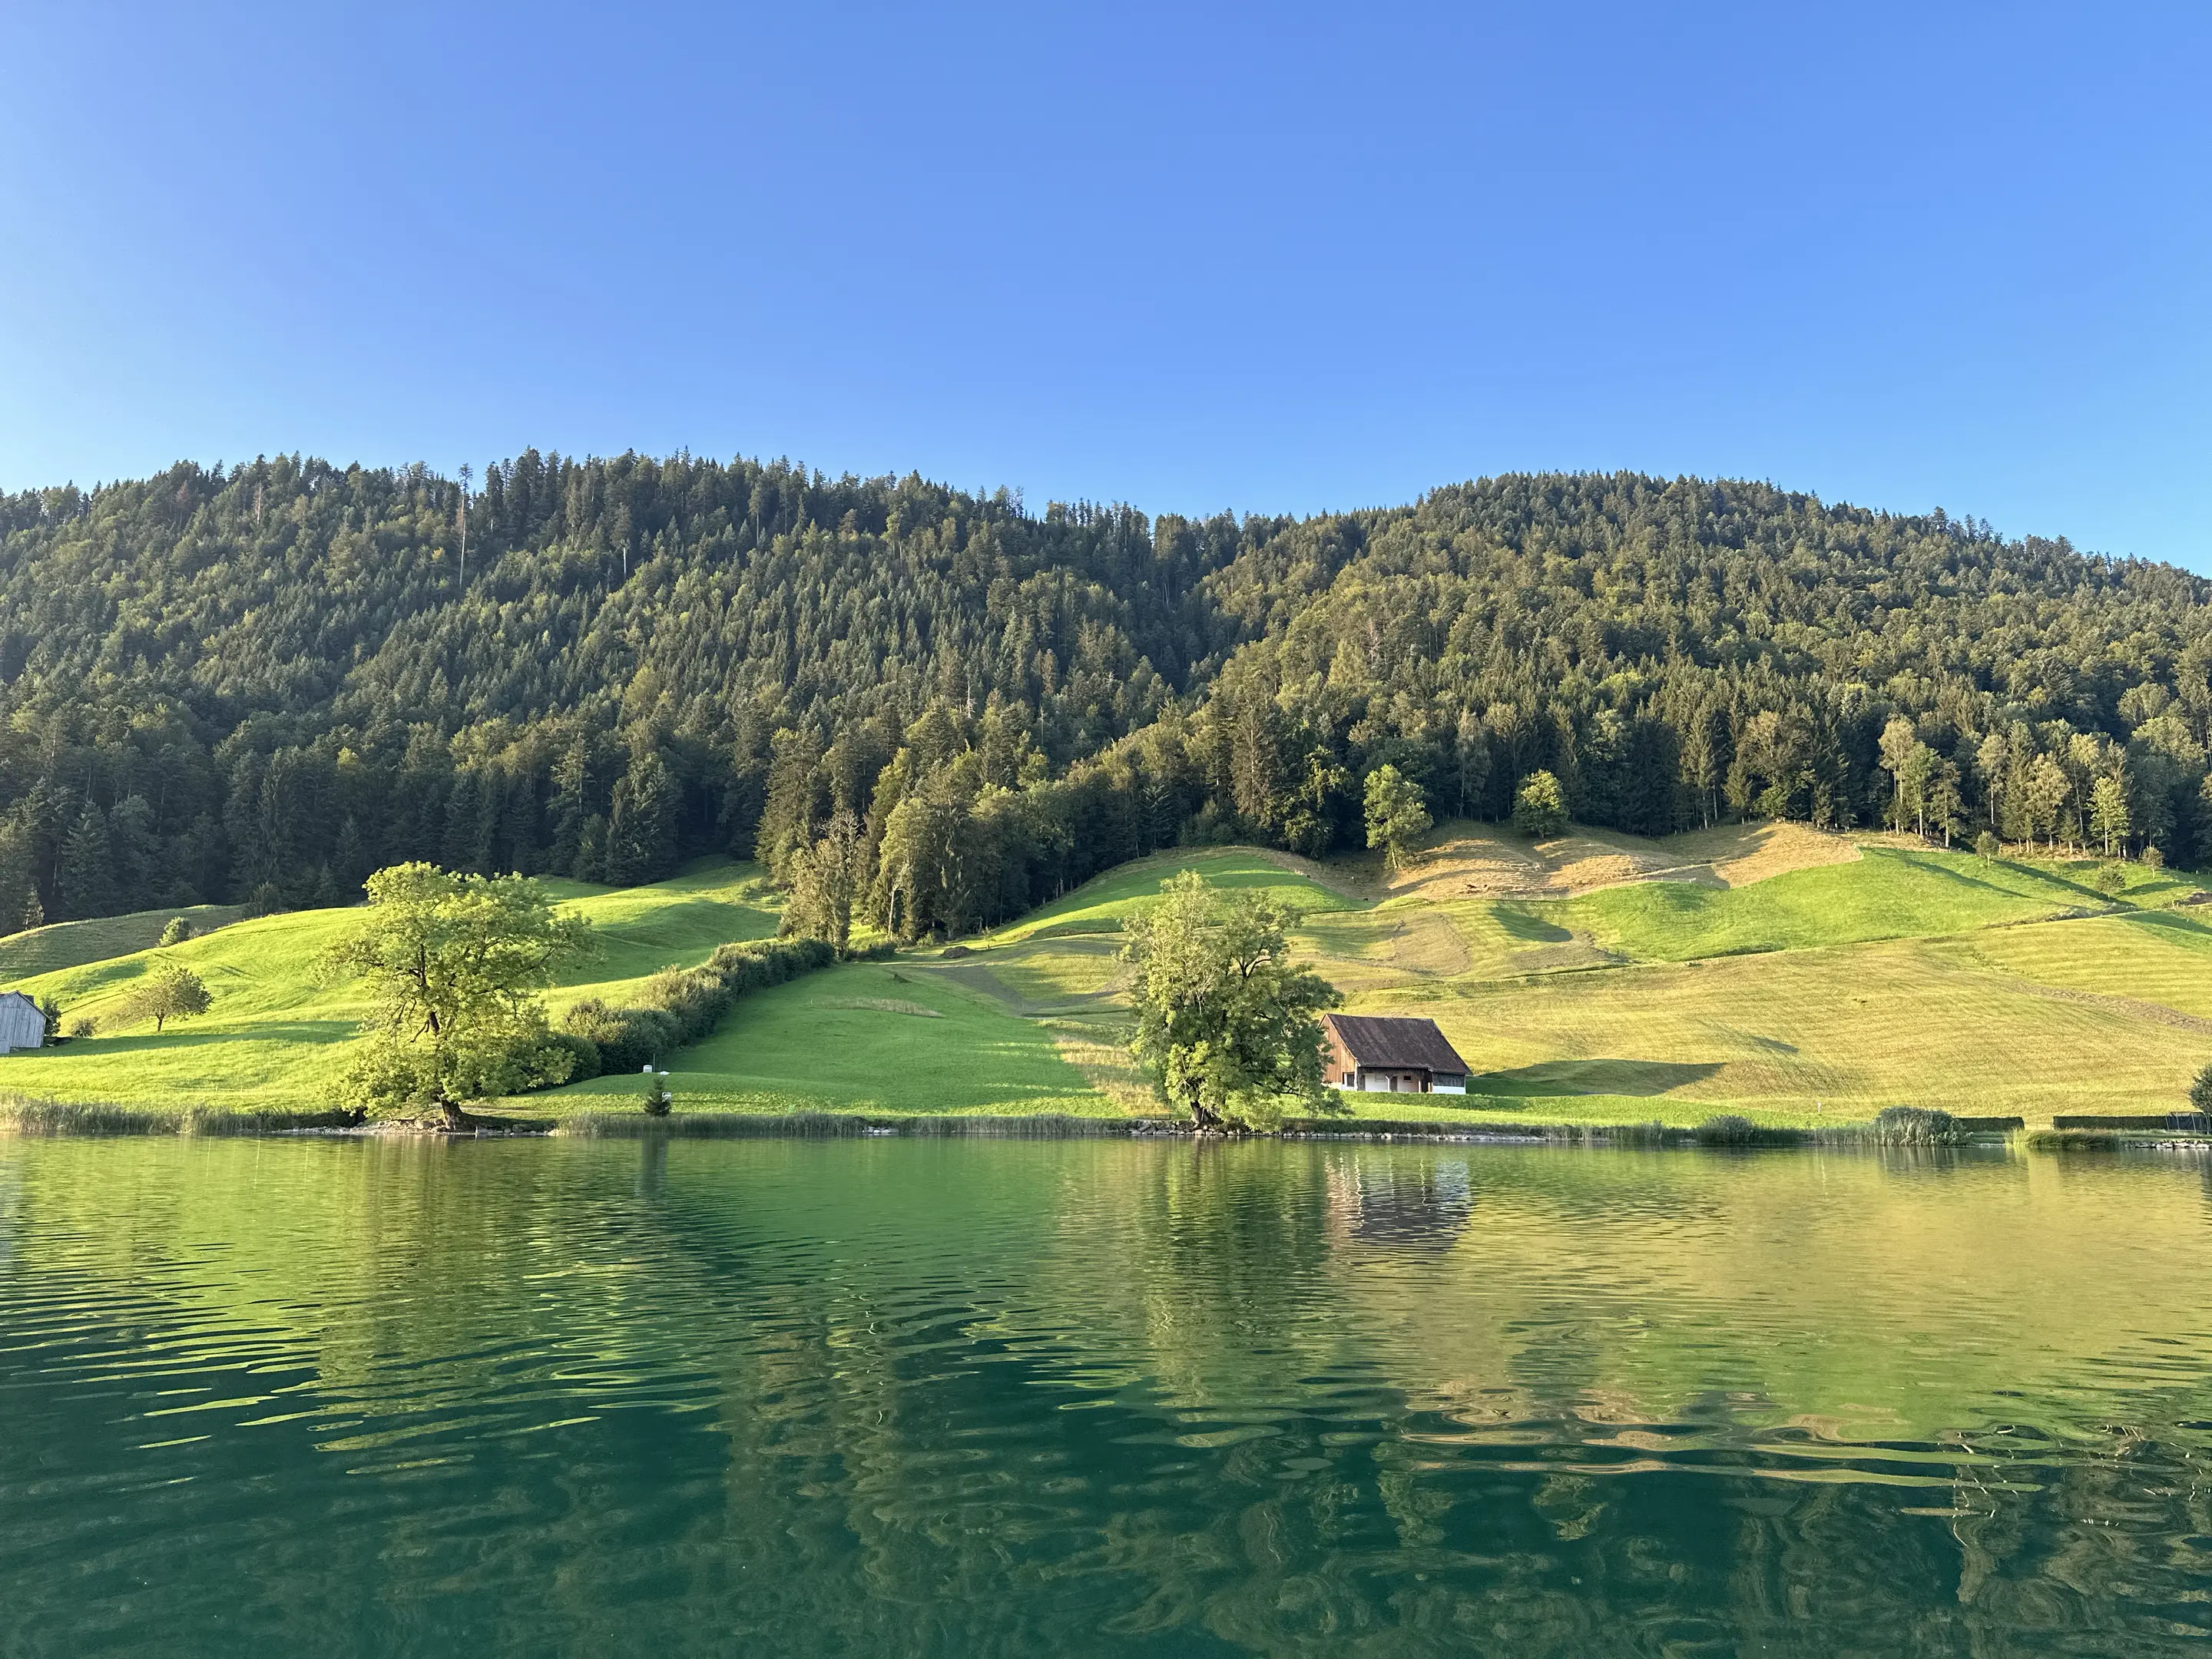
[[0, 827, 2212, 1126]]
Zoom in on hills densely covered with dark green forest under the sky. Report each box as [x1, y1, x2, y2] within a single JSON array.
[[0, 452, 2212, 931]]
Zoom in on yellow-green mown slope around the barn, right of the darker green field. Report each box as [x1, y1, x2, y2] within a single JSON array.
[[902, 832, 2212, 1124]]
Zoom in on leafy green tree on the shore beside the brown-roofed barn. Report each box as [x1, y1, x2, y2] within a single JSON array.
[[1121, 869, 1340, 1133]]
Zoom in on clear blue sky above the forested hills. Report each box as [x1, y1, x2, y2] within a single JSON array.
[[0, 0, 2212, 568]]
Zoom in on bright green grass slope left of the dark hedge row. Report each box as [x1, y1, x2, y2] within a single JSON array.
[[0, 865, 777, 1111]]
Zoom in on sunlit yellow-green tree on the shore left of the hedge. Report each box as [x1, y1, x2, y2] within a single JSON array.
[[325, 863, 591, 1128]]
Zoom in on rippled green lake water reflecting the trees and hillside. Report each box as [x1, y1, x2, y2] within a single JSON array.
[[0, 1139, 2212, 1659]]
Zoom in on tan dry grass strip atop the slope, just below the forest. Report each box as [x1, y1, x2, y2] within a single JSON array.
[[1389, 823, 1858, 902]]
